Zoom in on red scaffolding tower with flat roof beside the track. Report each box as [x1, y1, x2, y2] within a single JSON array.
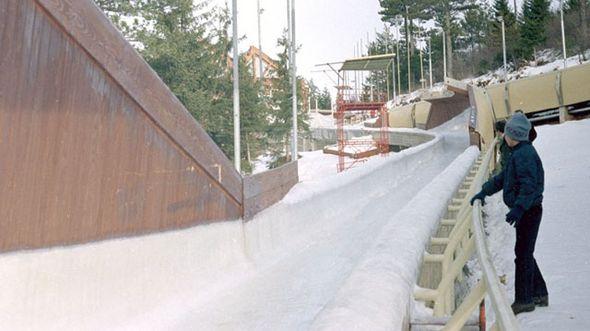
[[334, 54, 394, 172]]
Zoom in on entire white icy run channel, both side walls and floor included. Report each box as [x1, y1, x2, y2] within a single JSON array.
[[0, 114, 478, 330]]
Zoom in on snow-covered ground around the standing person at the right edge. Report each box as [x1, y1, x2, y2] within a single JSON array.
[[473, 120, 590, 331]]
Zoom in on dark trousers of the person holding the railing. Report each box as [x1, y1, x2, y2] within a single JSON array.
[[514, 205, 547, 303]]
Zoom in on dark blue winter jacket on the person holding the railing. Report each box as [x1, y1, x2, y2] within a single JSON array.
[[482, 141, 545, 211]]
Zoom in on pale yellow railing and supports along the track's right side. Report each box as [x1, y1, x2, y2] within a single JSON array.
[[414, 140, 519, 330]]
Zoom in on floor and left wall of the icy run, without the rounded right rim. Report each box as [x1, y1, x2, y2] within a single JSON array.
[[0, 111, 468, 330]]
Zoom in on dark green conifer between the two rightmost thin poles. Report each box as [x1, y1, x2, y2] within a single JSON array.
[[520, 0, 551, 59]]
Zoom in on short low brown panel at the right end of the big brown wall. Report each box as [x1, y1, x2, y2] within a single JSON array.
[[244, 162, 299, 220]]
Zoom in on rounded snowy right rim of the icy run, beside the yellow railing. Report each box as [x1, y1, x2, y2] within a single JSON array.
[[313, 147, 479, 330]]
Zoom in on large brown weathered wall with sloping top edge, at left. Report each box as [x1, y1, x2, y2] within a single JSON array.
[[0, 0, 242, 252]]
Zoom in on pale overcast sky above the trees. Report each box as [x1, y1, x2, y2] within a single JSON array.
[[211, 0, 558, 91]]
